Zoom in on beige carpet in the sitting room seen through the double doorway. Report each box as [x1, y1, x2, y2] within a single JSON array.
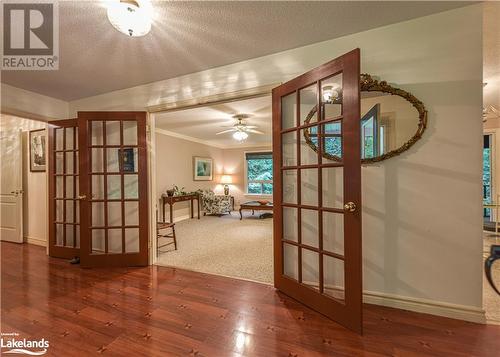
[[157, 212, 273, 284]]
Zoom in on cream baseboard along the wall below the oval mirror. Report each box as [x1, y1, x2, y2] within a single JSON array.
[[363, 291, 486, 324]]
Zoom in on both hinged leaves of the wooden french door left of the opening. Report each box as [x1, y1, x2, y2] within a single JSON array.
[[49, 112, 149, 267]]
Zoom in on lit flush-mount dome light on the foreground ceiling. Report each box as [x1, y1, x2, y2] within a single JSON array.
[[108, 0, 152, 37]]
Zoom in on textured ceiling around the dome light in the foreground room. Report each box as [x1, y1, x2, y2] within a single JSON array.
[[2, 1, 469, 101]]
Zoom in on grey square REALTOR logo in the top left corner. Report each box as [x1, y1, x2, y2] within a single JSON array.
[[1, 0, 59, 70]]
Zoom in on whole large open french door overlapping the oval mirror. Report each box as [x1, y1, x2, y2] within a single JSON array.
[[273, 49, 362, 333]]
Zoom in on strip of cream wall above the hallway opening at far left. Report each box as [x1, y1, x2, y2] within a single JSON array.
[[1, 83, 69, 120]]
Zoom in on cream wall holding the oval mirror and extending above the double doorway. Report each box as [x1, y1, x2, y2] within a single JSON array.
[[70, 4, 482, 318]]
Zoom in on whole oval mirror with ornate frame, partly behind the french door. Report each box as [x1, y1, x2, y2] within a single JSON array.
[[304, 74, 427, 164]]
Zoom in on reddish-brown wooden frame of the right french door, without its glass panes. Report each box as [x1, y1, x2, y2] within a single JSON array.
[[272, 49, 362, 333]]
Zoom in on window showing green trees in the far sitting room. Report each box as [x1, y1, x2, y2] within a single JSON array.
[[245, 152, 273, 195]]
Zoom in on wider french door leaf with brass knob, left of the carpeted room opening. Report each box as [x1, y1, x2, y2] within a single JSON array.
[[78, 112, 148, 267]]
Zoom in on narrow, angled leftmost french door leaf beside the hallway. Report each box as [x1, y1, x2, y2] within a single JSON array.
[[48, 119, 80, 259]]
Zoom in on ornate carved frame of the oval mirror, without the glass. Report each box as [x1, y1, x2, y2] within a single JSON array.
[[304, 73, 427, 164]]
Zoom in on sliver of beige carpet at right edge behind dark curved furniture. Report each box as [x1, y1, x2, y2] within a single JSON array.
[[483, 232, 500, 324]]
